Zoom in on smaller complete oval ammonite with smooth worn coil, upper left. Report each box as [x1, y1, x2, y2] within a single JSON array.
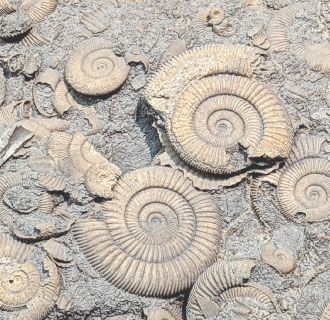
[[65, 38, 129, 96]]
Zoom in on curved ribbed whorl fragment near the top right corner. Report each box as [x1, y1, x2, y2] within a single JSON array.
[[269, 3, 304, 52]]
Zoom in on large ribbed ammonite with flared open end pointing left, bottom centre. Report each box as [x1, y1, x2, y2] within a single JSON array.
[[74, 167, 221, 296]]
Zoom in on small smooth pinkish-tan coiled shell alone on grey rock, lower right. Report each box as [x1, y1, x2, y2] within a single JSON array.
[[261, 243, 295, 273]]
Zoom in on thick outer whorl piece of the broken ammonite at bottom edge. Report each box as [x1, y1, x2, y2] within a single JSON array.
[[186, 260, 255, 320]]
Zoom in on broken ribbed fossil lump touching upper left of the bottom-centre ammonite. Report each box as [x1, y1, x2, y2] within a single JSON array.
[[48, 133, 121, 198]]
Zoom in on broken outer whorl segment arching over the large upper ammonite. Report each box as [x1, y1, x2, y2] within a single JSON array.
[[144, 45, 260, 112]]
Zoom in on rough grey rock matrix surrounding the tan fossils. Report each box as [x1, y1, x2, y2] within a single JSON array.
[[0, 0, 330, 320]]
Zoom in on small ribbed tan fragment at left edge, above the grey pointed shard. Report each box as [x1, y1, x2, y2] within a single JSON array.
[[0, 100, 32, 130]]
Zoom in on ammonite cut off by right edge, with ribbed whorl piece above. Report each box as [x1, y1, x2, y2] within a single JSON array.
[[254, 136, 330, 222]]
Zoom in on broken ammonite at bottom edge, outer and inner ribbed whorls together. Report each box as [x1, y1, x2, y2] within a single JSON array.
[[186, 260, 275, 320]]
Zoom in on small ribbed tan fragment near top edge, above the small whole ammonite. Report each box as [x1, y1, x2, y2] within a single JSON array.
[[81, 3, 110, 33]]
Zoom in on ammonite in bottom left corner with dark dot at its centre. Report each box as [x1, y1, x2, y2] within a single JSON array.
[[0, 234, 61, 320]]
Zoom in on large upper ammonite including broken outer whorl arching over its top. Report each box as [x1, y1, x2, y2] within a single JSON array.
[[145, 46, 292, 189]]
